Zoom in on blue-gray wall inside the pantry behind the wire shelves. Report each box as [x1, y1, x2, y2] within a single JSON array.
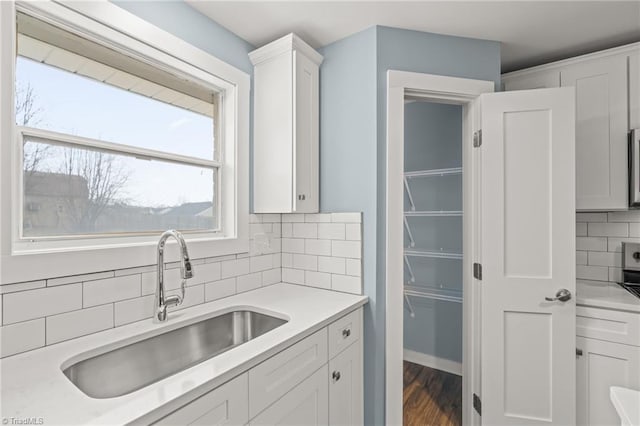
[[403, 102, 462, 362]]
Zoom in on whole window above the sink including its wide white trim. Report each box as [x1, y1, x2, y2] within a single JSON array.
[[0, 1, 250, 284]]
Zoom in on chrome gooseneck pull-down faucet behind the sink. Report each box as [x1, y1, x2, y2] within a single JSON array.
[[153, 229, 193, 322]]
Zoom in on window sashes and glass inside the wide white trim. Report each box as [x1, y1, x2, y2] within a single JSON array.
[[15, 13, 220, 239]]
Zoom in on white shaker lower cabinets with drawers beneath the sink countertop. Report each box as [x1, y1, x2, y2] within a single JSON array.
[[156, 308, 364, 426]]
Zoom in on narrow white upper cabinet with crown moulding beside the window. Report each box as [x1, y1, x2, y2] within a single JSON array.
[[249, 34, 323, 213]]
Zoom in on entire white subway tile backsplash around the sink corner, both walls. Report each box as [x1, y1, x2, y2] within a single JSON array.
[[0, 213, 362, 357]]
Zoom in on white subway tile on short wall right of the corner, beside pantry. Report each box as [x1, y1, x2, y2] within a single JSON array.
[[282, 213, 362, 294]]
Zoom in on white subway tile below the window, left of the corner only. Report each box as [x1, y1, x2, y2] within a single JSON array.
[[0, 214, 282, 357]]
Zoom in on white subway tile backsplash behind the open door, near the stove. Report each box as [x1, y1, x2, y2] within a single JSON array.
[[576, 210, 640, 282]]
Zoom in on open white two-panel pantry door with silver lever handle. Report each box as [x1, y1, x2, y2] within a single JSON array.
[[475, 88, 576, 425]]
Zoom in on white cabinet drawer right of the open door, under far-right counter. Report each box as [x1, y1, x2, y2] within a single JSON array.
[[576, 306, 640, 346]]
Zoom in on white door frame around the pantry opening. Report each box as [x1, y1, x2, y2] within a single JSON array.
[[385, 70, 495, 425]]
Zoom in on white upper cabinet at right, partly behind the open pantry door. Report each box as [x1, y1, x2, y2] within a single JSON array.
[[503, 43, 640, 211]]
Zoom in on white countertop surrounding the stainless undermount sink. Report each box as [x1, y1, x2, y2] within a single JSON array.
[[0, 284, 367, 425]]
